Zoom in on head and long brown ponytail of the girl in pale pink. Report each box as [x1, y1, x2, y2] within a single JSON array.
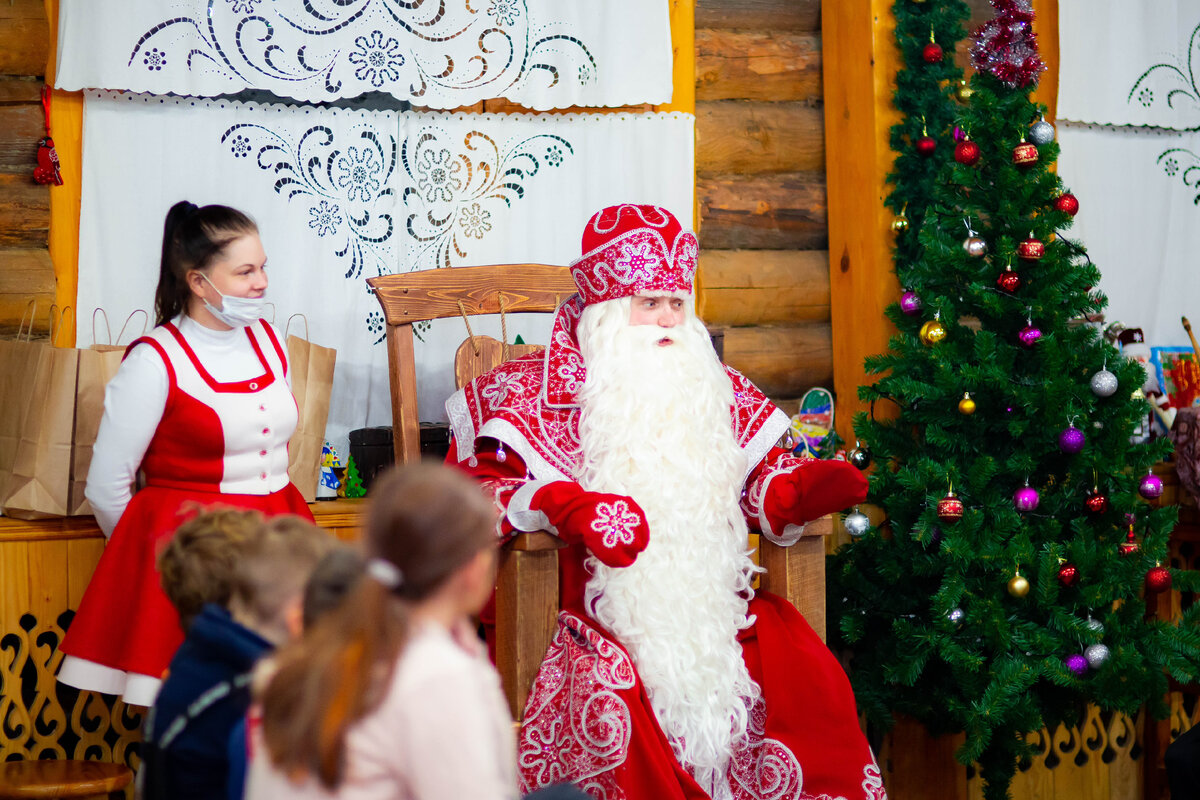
[[263, 464, 496, 789]]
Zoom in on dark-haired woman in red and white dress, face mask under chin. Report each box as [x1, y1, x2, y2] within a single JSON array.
[[59, 201, 312, 705]]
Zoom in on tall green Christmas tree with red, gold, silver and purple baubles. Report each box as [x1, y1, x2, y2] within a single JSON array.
[[829, 0, 1200, 800]]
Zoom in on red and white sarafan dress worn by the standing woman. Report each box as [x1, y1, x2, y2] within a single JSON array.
[[59, 318, 312, 705]]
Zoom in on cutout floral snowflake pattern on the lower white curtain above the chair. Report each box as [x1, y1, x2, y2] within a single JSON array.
[[221, 115, 575, 344]]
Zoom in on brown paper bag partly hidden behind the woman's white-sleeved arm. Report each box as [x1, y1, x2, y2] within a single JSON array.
[[67, 308, 150, 517]]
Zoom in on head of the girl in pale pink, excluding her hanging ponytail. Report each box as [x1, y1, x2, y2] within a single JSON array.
[[366, 464, 496, 612]]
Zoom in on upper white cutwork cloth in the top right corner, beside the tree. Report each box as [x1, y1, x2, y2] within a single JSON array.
[[1058, 0, 1200, 130]]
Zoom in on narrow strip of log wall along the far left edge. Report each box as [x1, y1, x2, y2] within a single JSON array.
[[0, 0, 54, 333]]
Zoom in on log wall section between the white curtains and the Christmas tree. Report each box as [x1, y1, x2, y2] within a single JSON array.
[[696, 0, 833, 405]]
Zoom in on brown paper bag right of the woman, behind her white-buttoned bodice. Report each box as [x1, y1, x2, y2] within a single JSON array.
[[284, 314, 337, 503]]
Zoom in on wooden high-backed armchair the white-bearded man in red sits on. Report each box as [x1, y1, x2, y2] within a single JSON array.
[[367, 264, 832, 721]]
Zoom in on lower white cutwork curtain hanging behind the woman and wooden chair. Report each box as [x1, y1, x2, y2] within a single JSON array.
[[78, 91, 694, 446]]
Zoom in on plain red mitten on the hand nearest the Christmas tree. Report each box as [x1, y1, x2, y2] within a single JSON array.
[[762, 461, 866, 533]]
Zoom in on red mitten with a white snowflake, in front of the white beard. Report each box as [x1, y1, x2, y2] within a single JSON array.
[[529, 481, 650, 566]]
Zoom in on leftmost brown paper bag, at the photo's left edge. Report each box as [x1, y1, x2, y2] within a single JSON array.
[[0, 304, 79, 519]]
